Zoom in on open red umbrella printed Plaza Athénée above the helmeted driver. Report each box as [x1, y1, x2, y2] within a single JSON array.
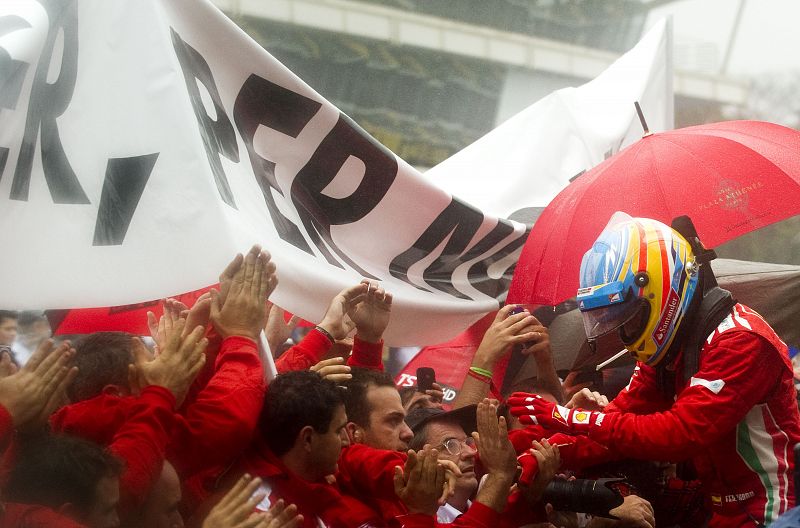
[[508, 121, 800, 305]]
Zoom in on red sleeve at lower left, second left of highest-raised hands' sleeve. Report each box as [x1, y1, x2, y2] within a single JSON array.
[[109, 385, 175, 516]]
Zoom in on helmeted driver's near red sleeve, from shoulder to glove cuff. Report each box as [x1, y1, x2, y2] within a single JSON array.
[[589, 332, 788, 461]]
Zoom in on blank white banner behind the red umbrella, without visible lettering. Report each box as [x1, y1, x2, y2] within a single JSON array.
[[425, 21, 674, 223]]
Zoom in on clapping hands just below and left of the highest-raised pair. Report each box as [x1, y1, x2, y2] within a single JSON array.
[[129, 319, 208, 407]]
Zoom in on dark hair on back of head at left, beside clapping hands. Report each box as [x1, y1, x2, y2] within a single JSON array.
[[67, 332, 133, 402]]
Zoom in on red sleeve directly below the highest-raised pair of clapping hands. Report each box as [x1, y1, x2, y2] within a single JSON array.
[[170, 336, 266, 478]]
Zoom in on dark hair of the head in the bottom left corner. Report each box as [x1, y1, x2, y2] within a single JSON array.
[[3, 435, 123, 514]]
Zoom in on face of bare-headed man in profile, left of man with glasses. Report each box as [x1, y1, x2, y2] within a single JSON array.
[[362, 385, 414, 451]]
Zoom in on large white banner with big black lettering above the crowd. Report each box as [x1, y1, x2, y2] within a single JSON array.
[[0, 0, 526, 345]]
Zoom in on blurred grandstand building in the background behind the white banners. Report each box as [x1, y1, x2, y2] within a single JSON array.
[[214, 0, 747, 169]]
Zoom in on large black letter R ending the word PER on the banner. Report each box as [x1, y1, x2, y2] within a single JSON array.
[[292, 114, 397, 279]]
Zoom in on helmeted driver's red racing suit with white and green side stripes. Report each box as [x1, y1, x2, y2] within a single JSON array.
[[589, 304, 800, 526]]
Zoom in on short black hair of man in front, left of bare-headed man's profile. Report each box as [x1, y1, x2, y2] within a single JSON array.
[[258, 370, 343, 456]]
